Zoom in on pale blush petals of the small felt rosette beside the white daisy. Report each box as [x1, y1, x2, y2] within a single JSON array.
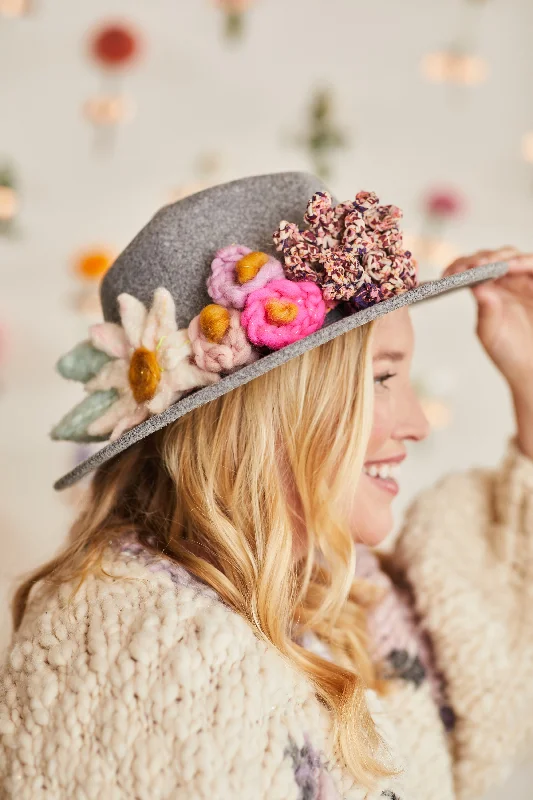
[[188, 309, 259, 372]]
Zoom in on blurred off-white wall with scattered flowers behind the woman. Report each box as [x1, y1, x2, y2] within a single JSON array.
[[0, 0, 533, 800]]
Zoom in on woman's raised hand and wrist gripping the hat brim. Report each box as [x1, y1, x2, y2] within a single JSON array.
[[444, 247, 533, 396]]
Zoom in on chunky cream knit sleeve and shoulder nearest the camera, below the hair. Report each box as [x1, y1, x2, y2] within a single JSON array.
[[0, 548, 396, 800]]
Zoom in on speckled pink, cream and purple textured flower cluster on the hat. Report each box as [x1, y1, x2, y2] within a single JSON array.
[[274, 192, 417, 308]]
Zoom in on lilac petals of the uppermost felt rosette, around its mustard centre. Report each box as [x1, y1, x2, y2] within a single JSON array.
[[207, 244, 284, 310]]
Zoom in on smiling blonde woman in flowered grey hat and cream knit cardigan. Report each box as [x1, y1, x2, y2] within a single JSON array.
[[0, 174, 533, 800]]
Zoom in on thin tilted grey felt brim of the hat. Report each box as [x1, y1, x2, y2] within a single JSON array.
[[54, 262, 508, 491]]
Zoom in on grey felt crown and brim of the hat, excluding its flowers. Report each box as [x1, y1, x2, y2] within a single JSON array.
[[51, 172, 507, 490]]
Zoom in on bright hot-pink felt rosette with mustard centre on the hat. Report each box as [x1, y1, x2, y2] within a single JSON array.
[[241, 278, 326, 350]]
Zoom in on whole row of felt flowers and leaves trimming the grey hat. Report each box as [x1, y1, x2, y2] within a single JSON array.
[[51, 192, 417, 442]]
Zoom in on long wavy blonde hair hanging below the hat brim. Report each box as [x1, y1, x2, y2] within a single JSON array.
[[13, 326, 391, 786]]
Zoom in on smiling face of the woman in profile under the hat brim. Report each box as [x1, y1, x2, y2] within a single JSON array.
[[351, 308, 429, 545]]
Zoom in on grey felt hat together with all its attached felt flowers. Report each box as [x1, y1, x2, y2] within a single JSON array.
[[51, 172, 508, 488]]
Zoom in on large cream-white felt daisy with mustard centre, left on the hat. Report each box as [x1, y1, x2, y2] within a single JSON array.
[[86, 288, 220, 441]]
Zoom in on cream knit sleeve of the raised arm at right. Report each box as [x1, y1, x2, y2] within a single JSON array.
[[395, 440, 533, 800]]
